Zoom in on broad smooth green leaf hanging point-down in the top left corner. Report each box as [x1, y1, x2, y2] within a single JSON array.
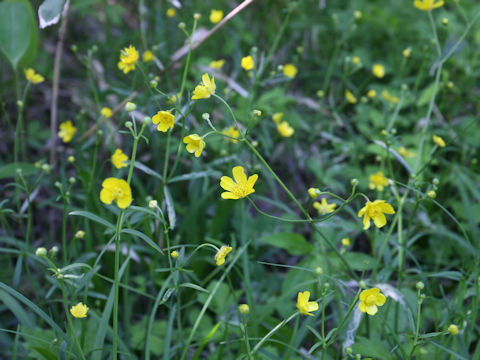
[[0, 1, 32, 69]]
